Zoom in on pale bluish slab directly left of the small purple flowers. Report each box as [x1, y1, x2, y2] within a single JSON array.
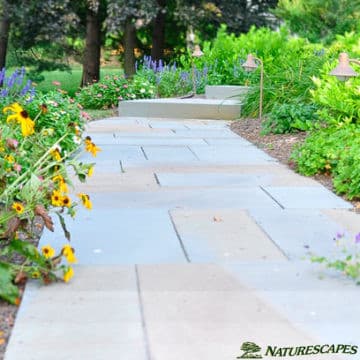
[[250, 209, 341, 259]]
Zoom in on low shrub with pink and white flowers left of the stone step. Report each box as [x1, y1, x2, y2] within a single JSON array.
[[75, 75, 155, 109]]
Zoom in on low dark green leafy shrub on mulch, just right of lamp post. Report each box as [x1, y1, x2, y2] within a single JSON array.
[[262, 103, 318, 134]]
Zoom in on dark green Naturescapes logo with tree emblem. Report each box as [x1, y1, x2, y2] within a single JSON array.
[[237, 341, 358, 359]]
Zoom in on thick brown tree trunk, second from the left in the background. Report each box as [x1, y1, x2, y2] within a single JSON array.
[[81, 9, 101, 87]]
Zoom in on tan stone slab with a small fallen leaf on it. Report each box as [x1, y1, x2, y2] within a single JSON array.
[[171, 209, 285, 263]]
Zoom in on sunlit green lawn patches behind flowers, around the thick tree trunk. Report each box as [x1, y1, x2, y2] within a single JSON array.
[[36, 67, 123, 96]]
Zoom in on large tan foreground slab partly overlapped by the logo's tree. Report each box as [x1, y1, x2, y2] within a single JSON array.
[[139, 264, 315, 360]]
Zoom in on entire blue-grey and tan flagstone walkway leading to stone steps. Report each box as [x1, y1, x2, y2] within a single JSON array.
[[6, 117, 360, 360]]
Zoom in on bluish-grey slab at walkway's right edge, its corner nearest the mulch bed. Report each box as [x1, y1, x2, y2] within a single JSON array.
[[265, 186, 352, 209]]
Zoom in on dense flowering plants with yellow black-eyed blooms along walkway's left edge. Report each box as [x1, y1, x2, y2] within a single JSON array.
[[0, 70, 100, 304]]
